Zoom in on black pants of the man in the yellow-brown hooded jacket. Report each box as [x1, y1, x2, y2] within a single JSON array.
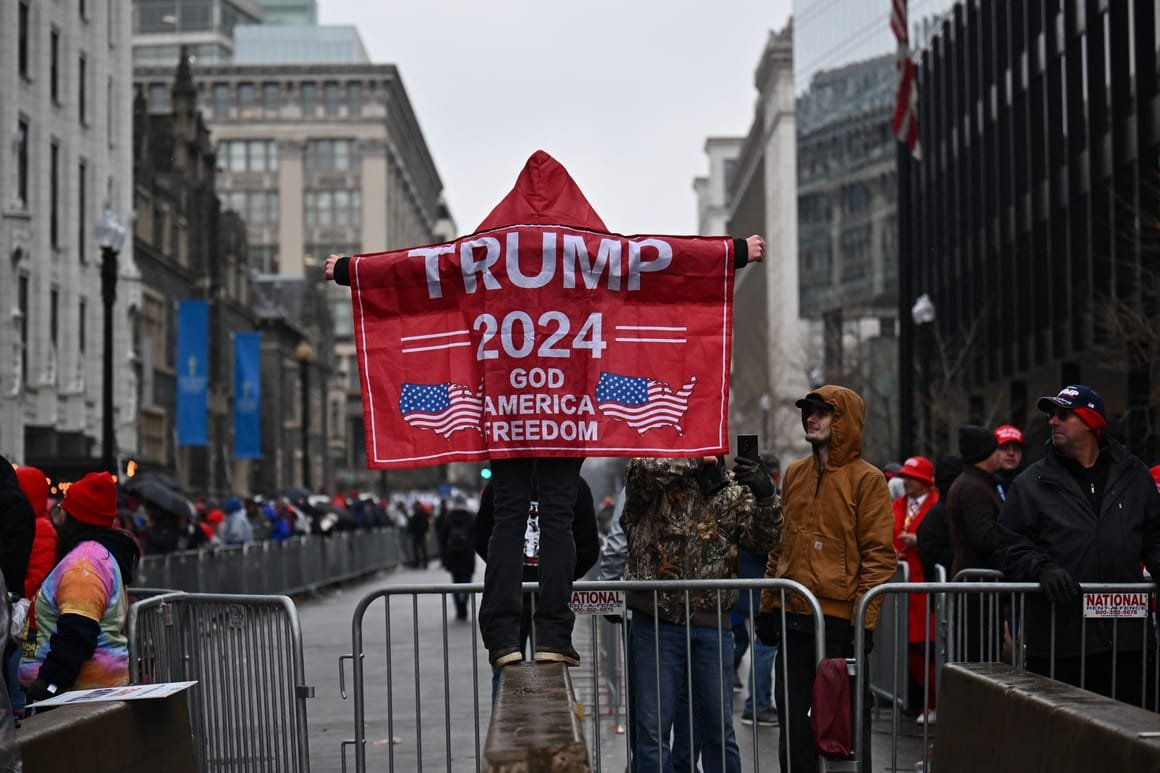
[[774, 614, 872, 773]]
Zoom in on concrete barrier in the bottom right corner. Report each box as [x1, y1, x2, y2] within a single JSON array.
[[931, 663, 1160, 773]]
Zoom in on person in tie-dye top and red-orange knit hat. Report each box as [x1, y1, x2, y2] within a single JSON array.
[[20, 472, 140, 701]]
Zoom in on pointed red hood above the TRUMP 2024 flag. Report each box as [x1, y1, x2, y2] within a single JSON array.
[[476, 150, 608, 233]]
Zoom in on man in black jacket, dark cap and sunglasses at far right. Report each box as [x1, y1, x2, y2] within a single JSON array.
[[995, 384, 1160, 705]]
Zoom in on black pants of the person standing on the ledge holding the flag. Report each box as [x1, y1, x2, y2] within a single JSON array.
[[479, 457, 583, 652]]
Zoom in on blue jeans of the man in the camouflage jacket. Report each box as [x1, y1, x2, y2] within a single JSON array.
[[629, 613, 741, 773]]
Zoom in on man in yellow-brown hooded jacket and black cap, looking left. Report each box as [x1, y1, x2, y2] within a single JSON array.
[[757, 385, 897, 773]]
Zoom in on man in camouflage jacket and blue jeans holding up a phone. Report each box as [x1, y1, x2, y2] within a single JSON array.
[[621, 456, 782, 773]]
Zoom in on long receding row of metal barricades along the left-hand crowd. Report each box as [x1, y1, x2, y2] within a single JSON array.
[[136, 528, 400, 594]]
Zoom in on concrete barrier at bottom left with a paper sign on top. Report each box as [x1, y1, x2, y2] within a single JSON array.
[[16, 692, 197, 773]]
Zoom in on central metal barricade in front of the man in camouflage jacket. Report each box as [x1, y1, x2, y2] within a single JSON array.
[[339, 579, 836, 772]]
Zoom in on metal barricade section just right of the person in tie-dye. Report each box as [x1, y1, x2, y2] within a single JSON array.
[[129, 593, 313, 773]]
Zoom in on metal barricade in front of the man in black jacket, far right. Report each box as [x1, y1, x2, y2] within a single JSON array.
[[854, 578, 1160, 770]]
